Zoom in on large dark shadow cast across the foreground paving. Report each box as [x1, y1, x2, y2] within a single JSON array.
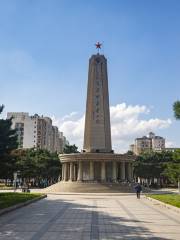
[[0, 198, 173, 240]]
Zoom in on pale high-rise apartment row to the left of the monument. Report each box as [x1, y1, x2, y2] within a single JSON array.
[[7, 112, 65, 153]]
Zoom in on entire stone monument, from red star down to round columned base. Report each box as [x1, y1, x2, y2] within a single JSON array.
[[45, 42, 134, 192]]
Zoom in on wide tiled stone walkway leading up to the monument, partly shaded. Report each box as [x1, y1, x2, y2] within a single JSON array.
[[0, 194, 180, 240]]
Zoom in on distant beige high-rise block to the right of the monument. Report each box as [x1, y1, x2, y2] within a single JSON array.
[[130, 132, 165, 155]]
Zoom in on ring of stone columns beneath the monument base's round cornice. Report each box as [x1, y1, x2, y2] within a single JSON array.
[[62, 161, 133, 182]]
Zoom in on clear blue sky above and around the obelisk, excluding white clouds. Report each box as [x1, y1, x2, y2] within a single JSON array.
[[0, 0, 180, 151]]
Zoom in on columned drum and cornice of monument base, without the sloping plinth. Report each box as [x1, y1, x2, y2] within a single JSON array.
[[59, 152, 135, 183]]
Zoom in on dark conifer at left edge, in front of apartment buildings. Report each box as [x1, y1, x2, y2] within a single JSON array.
[[0, 105, 18, 179]]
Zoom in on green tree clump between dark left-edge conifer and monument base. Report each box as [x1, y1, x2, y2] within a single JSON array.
[[13, 149, 61, 187]]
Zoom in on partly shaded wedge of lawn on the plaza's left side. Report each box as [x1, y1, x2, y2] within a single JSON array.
[[0, 192, 43, 209]]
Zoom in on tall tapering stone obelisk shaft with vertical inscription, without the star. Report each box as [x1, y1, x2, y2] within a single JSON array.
[[83, 46, 112, 153]]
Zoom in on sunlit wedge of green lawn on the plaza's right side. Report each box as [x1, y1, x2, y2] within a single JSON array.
[[146, 194, 180, 208]]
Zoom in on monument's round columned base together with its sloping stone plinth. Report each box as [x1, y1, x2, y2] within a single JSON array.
[[44, 152, 135, 193]]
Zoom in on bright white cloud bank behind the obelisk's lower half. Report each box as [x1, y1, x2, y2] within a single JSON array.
[[52, 103, 172, 152]]
